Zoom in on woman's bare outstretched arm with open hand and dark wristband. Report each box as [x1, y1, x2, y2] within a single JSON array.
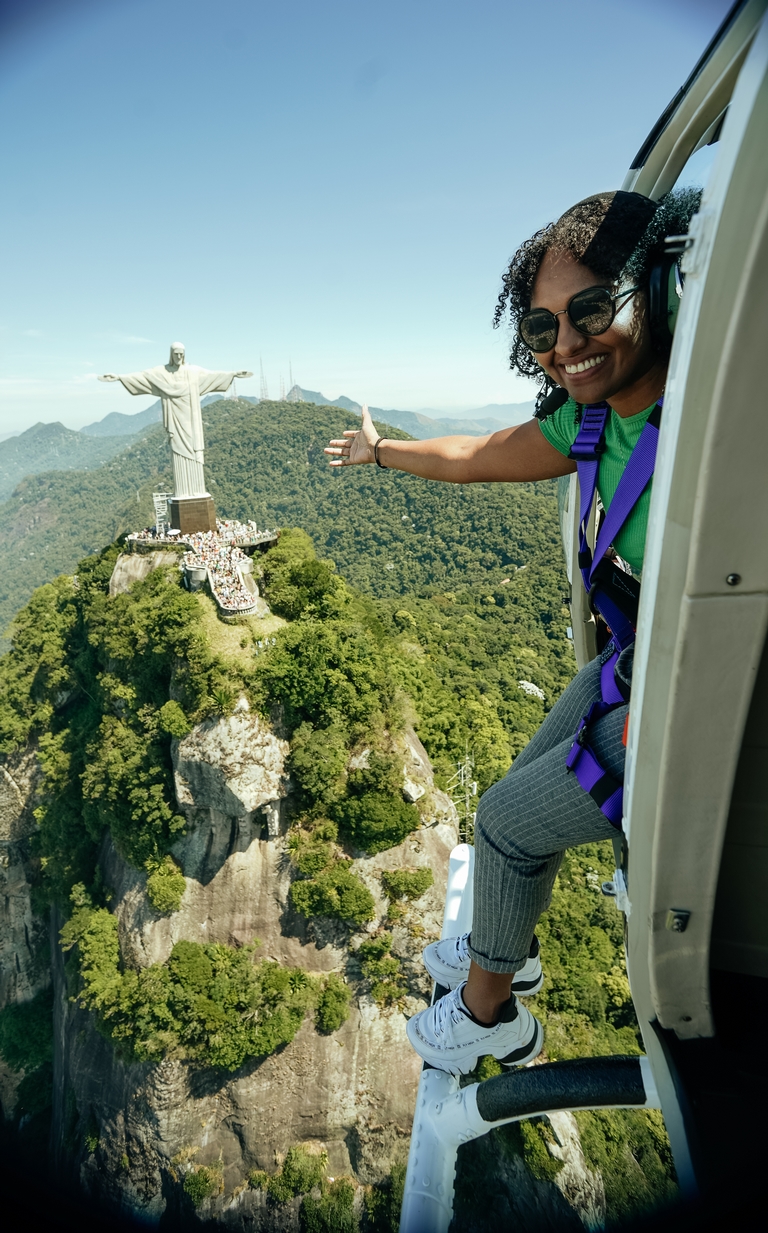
[[325, 407, 576, 483]]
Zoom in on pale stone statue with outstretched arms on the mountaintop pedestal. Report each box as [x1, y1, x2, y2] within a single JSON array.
[[99, 343, 253, 502]]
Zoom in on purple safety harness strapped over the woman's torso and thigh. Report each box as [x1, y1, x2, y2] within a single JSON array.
[[566, 398, 663, 829]]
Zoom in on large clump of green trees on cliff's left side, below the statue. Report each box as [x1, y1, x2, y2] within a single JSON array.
[[9, 546, 218, 906]]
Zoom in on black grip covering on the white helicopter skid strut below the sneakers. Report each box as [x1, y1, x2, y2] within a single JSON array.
[[477, 1055, 647, 1122]]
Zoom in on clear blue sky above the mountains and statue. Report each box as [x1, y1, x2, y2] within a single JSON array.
[[0, 0, 729, 433]]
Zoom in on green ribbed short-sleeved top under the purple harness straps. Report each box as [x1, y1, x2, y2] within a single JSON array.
[[539, 398, 656, 576]]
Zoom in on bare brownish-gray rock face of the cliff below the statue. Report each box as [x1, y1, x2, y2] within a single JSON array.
[[54, 707, 456, 1229]]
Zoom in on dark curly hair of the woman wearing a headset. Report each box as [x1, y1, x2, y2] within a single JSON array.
[[493, 187, 701, 399]]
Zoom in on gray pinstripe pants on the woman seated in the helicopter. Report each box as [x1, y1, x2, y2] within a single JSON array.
[[470, 651, 627, 972]]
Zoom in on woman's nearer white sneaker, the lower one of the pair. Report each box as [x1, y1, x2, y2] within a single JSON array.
[[406, 981, 544, 1075]]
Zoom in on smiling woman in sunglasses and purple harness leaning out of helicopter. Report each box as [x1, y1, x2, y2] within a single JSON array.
[[325, 190, 700, 1074]]
